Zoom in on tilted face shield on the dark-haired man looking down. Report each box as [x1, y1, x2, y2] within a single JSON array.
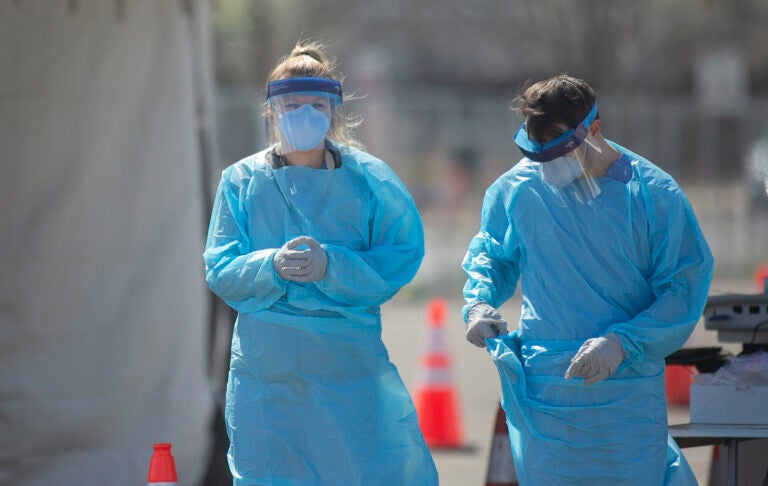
[[515, 103, 602, 206]]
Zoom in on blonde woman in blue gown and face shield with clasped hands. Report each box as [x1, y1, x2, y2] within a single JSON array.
[[204, 41, 437, 486]]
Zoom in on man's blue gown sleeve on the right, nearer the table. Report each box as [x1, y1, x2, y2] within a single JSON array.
[[606, 184, 713, 365]]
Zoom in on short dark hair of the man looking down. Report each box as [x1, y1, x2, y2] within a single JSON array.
[[515, 74, 595, 143]]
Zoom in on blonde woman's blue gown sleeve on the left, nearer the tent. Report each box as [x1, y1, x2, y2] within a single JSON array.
[[203, 167, 286, 312]]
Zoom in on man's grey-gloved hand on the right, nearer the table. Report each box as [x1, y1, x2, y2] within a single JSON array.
[[565, 333, 624, 386]]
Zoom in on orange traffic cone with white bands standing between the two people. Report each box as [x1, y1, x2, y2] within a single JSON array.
[[414, 298, 462, 448]]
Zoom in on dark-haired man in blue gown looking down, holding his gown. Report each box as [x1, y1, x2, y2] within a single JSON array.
[[462, 75, 713, 486]]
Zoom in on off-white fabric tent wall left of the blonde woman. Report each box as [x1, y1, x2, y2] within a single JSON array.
[[0, 0, 212, 486]]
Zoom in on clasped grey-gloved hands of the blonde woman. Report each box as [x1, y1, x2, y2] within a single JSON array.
[[272, 236, 328, 282]]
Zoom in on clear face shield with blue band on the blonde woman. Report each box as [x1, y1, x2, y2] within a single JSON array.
[[267, 78, 346, 154]]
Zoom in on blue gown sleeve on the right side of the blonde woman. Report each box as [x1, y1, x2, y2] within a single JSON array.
[[315, 167, 424, 306]]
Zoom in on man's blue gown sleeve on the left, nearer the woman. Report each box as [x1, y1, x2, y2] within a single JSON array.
[[461, 182, 521, 321]]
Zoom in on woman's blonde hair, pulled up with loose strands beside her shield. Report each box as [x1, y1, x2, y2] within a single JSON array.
[[267, 40, 363, 149]]
